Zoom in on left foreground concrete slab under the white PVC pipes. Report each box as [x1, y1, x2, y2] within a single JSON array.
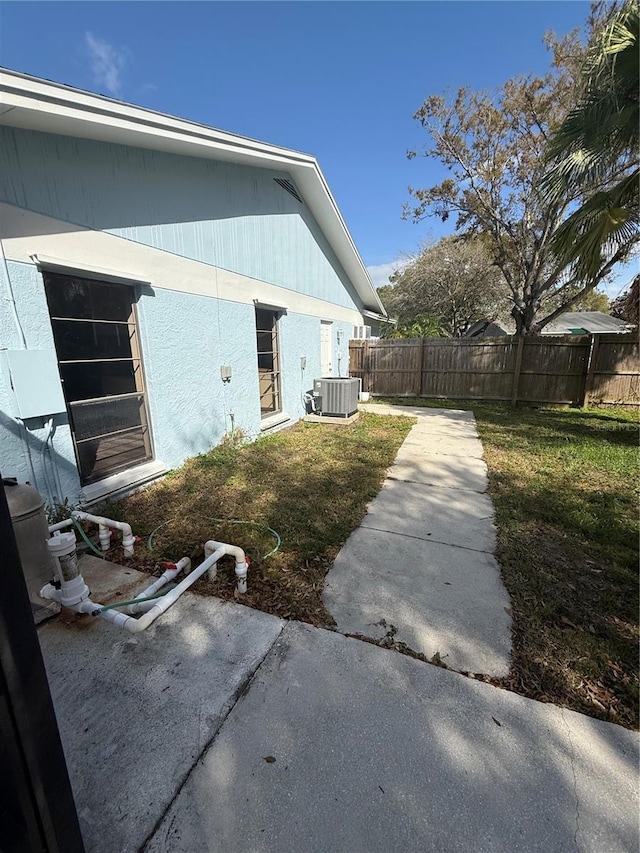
[[38, 558, 283, 853]]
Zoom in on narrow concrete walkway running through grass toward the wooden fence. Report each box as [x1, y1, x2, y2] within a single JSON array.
[[324, 405, 511, 676]]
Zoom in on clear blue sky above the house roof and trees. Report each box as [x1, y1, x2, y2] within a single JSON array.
[[0, 0, 629, 293]]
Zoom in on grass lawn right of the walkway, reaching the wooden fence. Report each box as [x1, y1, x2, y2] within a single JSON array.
[[379, 398, 639, 728]]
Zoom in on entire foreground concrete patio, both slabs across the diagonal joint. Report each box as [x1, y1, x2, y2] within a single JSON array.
[[39, 560, 638, 853]]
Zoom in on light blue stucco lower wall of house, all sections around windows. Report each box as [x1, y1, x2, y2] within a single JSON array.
[[0, 261, 351, 504]]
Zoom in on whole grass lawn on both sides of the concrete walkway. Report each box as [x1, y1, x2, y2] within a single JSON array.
[[99, 398, 639, 727]]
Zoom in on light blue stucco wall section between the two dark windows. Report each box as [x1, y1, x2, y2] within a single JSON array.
[[137, 288, 260, 467]]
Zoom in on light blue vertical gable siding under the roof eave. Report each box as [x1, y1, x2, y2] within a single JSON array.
[[0, 127, 359, 310]]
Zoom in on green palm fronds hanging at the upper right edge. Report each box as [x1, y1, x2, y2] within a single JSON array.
[[540, 0, 640, 281]]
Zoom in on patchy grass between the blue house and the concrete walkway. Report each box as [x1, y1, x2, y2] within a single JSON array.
[[103, 413, 414, 625]]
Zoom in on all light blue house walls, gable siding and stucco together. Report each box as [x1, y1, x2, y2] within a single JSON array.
[[0, 128, 360, 504]]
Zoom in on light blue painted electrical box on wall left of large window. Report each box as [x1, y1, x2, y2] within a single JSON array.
[[0, 349, 67, 420]]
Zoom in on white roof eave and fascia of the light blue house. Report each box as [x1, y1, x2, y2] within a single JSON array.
[[0, 68, 386, 317]]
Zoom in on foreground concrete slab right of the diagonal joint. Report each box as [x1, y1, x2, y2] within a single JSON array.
[[145, 623, 638, 853]]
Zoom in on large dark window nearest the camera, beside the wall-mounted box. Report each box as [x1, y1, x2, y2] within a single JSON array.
[[44, 272, 153, 485]]
